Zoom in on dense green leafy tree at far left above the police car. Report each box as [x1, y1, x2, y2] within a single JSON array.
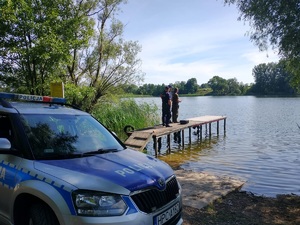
[[0, 0, 95, 95]]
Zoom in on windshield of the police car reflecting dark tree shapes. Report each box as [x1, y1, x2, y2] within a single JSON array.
[[22, 114, 123, 159]]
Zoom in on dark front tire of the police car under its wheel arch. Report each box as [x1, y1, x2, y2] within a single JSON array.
[[28, 204, 59, 225]]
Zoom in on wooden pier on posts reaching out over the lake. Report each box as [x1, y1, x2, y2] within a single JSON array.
[[125, 116, 226, 157]]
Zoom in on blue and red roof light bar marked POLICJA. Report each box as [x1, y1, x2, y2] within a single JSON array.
[[0, 92, 66, 103]]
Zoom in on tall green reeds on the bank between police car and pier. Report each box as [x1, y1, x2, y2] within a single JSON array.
[[92, 98, 160, 140]]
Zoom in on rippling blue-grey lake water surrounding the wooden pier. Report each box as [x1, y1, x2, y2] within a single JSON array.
[[136, 96, 300, 197]]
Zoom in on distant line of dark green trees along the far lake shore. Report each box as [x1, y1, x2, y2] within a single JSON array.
[[124, 62, 297, 96]]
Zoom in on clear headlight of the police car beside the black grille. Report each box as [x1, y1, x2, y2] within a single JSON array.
[[72, 190, 127, 216]]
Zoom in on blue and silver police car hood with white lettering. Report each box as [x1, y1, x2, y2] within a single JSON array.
[[35, 149, 174, 193]]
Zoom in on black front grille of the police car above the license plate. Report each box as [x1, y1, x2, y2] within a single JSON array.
[[131, 176, 179, 213]]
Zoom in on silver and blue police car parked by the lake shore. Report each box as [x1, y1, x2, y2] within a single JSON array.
[[0, 93, 182, 225]]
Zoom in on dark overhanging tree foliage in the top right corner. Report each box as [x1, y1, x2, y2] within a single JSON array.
[[224, 0, 300, 88]]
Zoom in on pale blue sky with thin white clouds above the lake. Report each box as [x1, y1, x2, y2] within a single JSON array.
[[118, 0, 278, 85]]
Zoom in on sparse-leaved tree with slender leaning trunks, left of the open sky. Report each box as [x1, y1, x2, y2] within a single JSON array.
[[63, 0, 143, 111]]
